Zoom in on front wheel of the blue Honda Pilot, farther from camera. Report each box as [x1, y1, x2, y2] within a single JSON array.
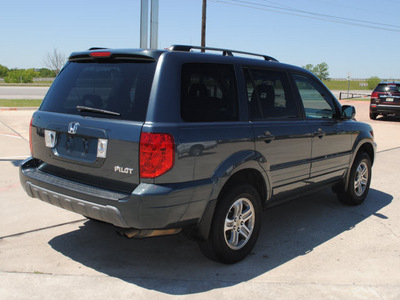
[[337, 152, 372, 205]]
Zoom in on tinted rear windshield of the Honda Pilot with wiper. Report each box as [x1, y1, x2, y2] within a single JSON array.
[[40, 61, 156, 121]]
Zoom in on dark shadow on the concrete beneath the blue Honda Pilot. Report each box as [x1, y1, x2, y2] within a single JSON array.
[[49, 189, 393, 295]]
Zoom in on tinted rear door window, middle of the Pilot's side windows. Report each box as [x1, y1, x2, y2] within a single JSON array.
[[244, 69, 299, 120]]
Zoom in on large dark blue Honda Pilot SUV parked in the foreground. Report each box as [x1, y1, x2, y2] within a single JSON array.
[[20, 46, 376, 263]]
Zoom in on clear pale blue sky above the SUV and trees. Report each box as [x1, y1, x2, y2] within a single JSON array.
[[0, 0, 400, 79]]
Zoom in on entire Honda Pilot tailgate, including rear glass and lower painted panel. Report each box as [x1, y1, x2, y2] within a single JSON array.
[[31, 52, 156, 193]]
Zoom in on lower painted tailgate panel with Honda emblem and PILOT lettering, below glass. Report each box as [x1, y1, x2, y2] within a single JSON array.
[[31, 111, 143, 192]]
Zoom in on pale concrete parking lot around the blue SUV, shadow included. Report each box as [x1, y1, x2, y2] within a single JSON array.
[[0, 101, 400, 299]]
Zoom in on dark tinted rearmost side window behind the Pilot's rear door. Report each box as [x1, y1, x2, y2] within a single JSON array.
[[181, 63, 239, 122]]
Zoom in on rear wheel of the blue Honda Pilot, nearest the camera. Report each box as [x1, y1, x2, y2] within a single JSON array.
[[199, 184, 261, 264]]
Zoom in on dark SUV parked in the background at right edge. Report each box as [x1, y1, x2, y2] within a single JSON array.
[[369, 81, 400, 120]]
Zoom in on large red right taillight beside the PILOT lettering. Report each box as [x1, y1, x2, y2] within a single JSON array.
[[139, 132, 175, 178]]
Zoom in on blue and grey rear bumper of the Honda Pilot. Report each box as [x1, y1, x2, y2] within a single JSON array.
[[20, 159, 213, 229]]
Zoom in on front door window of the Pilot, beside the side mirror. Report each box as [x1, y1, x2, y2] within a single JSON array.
[[293, 74, 335, 119]]
